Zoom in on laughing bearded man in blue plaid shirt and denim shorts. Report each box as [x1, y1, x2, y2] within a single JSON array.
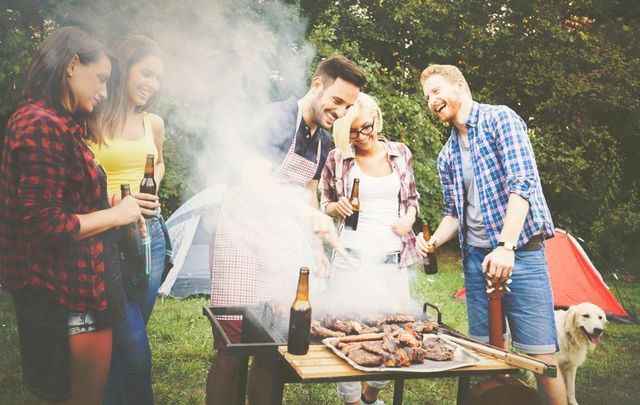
[[416, 65, 566, 404]]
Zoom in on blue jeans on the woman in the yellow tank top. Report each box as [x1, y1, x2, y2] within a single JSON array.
[[102, 218, 165, 405]]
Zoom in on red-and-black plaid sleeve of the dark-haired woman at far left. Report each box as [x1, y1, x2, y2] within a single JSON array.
[[15, 117, 80, 245]]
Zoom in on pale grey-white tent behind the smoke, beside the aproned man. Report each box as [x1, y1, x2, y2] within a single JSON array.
[[158, 185, 226, 298]]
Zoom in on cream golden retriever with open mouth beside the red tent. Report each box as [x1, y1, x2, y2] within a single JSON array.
[[555, 302, 607, 405]]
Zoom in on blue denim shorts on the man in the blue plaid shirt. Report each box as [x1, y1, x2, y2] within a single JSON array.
[[463, 244, 559, 354]]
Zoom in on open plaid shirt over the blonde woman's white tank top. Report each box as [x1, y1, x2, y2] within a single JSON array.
[[318, 136, 422, 267]]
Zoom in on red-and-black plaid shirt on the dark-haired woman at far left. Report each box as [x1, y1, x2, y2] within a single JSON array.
[[0, 100, 107, 311]]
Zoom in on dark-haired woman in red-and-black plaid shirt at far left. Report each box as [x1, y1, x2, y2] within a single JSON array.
[[0, 27, 142, 404]]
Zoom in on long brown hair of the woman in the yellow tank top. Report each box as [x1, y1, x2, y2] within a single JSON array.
[[91, 34, 165, 144]]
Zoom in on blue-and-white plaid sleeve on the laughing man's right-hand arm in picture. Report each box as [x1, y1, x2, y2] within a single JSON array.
[[492, 107, 538, 200]]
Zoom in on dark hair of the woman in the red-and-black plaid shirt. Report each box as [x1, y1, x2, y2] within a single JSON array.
[[23, 27, 110, 113]]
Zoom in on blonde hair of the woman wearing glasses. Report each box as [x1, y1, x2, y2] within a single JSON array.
[[333, 92, 382, 157]]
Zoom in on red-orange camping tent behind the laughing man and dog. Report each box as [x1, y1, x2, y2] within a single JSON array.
[[456, 229, 629, 319]]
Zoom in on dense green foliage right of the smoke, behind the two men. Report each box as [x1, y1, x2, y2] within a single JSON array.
[[295, 0, 640, 274]]
